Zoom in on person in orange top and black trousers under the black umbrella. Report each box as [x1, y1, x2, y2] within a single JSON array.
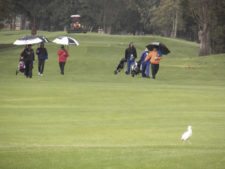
[[145, 48, 161, 79]]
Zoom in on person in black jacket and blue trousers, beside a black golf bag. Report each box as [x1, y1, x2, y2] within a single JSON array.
[[125, 42, 137, 75]]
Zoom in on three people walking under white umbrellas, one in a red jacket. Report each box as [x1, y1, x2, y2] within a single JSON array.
[[18, 43, 69, 78]]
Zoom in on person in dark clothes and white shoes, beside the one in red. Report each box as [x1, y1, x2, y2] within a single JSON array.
[[36, 43, 48, 76]]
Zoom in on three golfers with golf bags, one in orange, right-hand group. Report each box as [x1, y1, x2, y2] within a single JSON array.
[[114, 42, 162, 79]]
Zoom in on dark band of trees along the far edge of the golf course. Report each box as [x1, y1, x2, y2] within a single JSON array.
[[0, 0, 225, 56]]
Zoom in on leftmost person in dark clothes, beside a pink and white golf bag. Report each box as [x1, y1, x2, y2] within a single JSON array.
[[21, 45, 34, 78]]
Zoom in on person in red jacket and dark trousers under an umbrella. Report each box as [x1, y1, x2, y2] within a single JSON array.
[[57, 45, 69, 75]]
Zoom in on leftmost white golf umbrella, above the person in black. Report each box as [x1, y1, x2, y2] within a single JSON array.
[[13, 35, 43, 45]]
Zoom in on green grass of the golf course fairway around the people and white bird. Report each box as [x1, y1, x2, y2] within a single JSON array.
[[0, 31, 225, 169]]
